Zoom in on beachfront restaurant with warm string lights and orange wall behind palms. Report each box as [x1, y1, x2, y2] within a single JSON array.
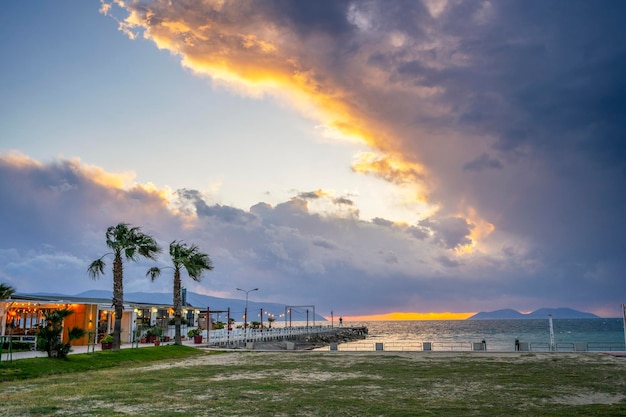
[[0, 293, 200, 346]]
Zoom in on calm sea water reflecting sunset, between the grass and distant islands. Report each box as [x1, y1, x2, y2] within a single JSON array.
[[334, 318, 625, 351]]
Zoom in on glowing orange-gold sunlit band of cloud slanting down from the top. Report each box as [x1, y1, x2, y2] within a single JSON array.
[[107, 1, 426, 183]]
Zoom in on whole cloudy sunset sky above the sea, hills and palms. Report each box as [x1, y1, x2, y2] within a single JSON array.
[[0, 0, 626, 318]]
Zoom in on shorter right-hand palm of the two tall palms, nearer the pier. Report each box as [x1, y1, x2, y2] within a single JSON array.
[[146, 241, 213, 345]]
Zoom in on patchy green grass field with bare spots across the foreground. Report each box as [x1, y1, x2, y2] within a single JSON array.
[[0, 346, 626, 416]]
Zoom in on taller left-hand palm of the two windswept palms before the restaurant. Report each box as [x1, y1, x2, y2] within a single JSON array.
[[87, 223, 161, 351]]
